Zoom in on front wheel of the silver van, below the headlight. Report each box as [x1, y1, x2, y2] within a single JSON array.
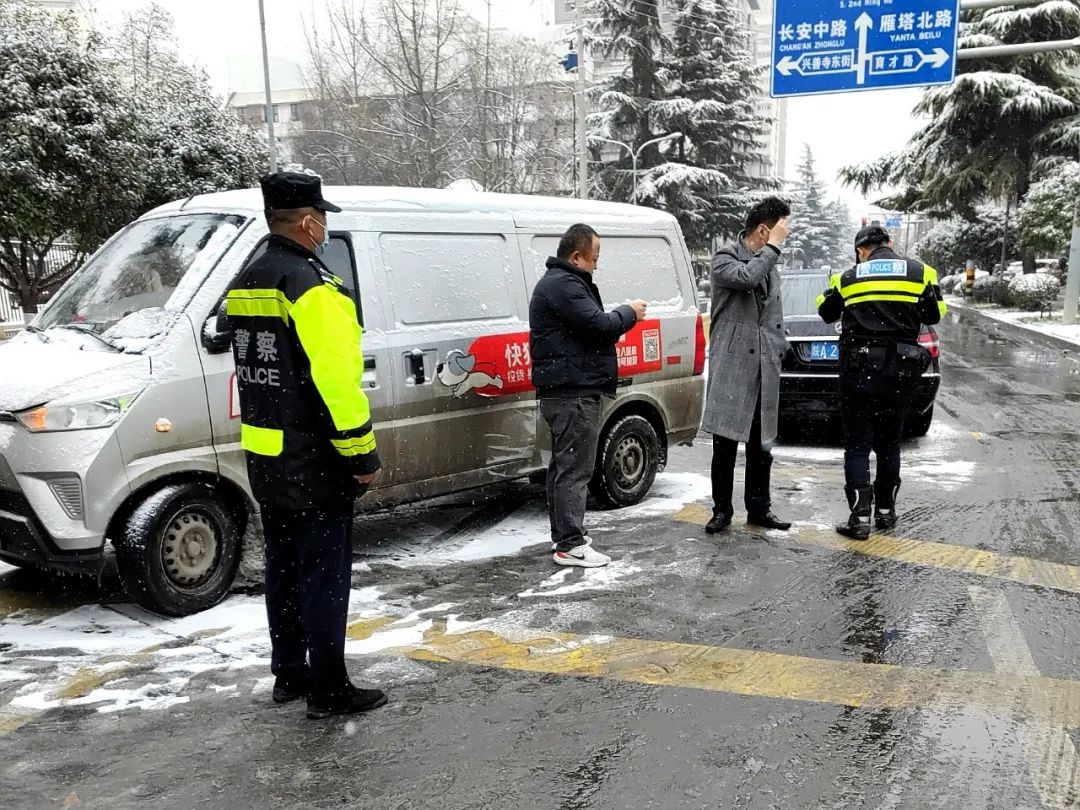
[[114, 484, 241, 616]]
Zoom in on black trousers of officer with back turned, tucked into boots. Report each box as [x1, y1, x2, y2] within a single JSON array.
[[840, 372, 908, 489]]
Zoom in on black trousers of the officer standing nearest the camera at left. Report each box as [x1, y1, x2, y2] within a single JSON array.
[[262, 509, 352, 697]]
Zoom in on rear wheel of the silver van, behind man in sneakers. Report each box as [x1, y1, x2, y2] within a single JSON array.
[[589, 416, 660, 508]]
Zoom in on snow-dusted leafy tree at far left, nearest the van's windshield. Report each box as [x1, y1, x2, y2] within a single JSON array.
[[0, 4, 145, 313]]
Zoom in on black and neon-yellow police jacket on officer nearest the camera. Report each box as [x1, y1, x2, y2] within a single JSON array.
[[227, 235, 380, 510]]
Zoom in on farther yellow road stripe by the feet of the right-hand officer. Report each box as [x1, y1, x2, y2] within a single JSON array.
[[675, 503, 1080, 593]]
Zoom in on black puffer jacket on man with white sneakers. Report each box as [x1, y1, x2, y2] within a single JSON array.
[[529, 258, 637, 396]]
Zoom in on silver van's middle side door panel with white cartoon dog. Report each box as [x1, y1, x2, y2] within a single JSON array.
[[370, 213, 538, 498]]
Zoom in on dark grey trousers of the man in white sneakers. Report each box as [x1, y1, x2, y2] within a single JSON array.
[[540, 396, 600, 551]]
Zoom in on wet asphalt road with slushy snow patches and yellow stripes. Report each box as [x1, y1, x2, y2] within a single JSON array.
[[0, 306, 1080, 810]]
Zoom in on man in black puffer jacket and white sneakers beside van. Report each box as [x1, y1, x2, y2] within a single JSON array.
[[529, 225, 646, 568]]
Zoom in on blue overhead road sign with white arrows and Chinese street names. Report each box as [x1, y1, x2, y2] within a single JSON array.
[[772, 0, 960, 98]]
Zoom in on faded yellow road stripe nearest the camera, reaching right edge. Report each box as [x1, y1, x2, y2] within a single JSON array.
[[388, 623, 1080, 728]]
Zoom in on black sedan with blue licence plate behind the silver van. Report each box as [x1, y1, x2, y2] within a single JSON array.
[[780, 270, 942, 437]]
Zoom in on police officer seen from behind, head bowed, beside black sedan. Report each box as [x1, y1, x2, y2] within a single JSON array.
[[818, 225, 945, 540]]
